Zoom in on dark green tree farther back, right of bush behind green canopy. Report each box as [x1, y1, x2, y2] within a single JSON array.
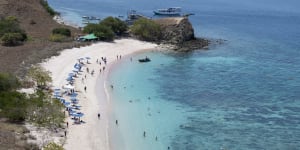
[[100, 17, 128, 35]]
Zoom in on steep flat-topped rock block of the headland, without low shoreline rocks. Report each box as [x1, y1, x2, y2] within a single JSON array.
[[155, 17, 195, 45]]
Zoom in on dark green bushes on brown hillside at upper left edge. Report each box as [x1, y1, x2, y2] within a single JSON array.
[[0, 16, 27, 46]]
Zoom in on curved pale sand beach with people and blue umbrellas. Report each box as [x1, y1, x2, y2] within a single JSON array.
[[42, 39, 157, 150]]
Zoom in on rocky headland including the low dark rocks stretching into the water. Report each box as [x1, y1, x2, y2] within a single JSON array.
[[154, 17, 209, 51]]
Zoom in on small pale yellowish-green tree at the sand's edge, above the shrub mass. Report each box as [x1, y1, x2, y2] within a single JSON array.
[[28, 65, 52, 87]]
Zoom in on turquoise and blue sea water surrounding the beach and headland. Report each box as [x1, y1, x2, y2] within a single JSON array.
[[49, 0, 300, 150]]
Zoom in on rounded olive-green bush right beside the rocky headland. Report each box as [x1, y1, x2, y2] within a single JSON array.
[[131, 18, 161, 41]]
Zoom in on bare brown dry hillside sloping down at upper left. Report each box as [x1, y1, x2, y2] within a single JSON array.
[[0, 0, 84, 75]]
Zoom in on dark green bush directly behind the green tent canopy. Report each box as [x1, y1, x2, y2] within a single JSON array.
[[83, 23, 114, 41]]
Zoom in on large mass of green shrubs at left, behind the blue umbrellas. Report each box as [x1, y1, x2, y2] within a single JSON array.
[[0, 66, 65, 128]]
